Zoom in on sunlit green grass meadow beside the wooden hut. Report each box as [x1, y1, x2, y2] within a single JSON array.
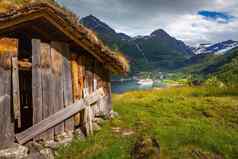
[[58, 87, 238, 159]]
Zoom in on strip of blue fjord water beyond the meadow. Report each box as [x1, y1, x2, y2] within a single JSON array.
[[112, 81, 163, 93]]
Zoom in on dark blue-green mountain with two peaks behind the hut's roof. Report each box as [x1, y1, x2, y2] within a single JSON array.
[[81, 15, 193, 72]]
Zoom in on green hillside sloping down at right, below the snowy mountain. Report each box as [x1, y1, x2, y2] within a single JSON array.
[[177, 48, 238, 85]]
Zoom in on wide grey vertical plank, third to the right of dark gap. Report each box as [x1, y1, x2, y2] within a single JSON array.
[[51, 42, 64, 136]]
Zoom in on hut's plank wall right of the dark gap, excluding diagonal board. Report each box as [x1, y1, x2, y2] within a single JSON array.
[[32, 39, 111, 140]]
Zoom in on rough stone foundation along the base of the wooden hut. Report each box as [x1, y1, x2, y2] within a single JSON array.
[[0, 115, 109, 159]]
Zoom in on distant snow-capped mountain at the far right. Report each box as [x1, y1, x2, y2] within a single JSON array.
[[193, 40, 238, 54]]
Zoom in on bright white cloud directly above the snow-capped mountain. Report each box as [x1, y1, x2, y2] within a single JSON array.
[[166, 15, 238, 45]]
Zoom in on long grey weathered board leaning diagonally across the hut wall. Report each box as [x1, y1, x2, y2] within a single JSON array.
[[16, 89, 104, 144]]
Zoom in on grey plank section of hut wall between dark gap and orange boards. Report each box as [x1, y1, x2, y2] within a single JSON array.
[[32, 39, 74, 140]]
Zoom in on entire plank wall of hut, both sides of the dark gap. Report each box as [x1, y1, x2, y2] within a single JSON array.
[[0, 36, 112, 149]]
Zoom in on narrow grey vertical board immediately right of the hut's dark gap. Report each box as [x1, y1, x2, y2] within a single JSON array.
[[32, 39, 43, 140]]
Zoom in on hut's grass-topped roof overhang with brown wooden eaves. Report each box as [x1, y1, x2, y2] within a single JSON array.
[[0, 3, 128, 74]]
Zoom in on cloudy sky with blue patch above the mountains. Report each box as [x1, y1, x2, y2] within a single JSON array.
[[57, 0, 238, 45]]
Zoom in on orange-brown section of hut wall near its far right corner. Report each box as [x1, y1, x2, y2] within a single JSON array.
[[71, 52, 112, 121]]
